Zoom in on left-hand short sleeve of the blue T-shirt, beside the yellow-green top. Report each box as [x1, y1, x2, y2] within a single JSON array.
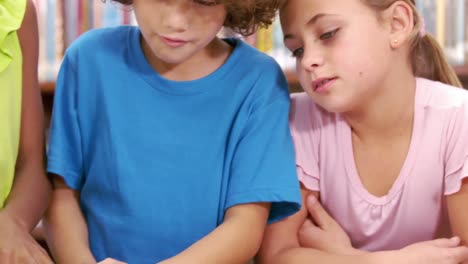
[[47, 54, 83, 190]]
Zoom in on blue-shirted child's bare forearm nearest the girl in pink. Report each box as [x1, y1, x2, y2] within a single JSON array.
[[161, 203, 270, 264]]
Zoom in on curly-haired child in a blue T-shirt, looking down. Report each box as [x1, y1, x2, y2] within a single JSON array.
[[46, 0, 301, 264]]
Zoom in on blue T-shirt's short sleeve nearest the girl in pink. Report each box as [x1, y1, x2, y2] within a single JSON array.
[[225, 67, 301, 223]]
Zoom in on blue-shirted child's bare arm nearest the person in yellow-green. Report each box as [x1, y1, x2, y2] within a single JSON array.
[[44, 175, 96, 264]]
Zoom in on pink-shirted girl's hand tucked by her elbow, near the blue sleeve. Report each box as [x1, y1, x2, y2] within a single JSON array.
[[299, 194, 359, 255]]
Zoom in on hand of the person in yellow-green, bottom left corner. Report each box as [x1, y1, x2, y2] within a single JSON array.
[[0, 211, 53, 264]]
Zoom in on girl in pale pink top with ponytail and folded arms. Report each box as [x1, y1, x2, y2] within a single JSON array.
[[259, 0, 468, 264]]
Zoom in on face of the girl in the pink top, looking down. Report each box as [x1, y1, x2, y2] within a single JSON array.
[[280, 0, 391, 112]]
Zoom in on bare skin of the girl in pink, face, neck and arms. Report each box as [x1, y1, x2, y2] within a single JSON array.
[[258, 0, 468, 264]]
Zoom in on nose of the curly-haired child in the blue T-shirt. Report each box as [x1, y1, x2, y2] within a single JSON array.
[[162, 0, 191, 32]]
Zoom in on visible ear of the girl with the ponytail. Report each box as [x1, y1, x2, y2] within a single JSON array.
[[385, 1, 414, 49]]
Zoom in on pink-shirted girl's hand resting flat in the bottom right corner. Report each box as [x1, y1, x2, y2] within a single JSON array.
[[389, 237, 468, 264]]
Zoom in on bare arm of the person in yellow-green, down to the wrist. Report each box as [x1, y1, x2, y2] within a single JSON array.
[[2, 0, 50, 232]]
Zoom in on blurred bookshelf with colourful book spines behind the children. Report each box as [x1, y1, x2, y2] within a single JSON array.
[[37, 0, 468, 93]]
